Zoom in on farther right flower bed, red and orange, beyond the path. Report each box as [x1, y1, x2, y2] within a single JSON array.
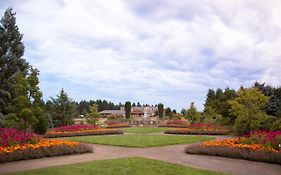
[[164, 123, 229, 135]]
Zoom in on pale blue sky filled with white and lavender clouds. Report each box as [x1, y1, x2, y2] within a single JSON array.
[[0, 0, 281, 110]]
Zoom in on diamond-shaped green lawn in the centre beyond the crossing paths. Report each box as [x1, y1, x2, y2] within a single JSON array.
[[68, 134, 214, 148]]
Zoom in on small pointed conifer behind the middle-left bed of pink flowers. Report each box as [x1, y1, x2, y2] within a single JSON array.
[[47, 89, 76, 127]]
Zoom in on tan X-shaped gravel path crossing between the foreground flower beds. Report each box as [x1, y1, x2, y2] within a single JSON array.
[[0, 136, 281, 175]]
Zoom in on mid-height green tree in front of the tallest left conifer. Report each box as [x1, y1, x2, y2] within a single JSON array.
[[7, 67, 46, 134]]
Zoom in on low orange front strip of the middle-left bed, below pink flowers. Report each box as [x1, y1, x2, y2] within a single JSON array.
[[44, 128, 123, 138]]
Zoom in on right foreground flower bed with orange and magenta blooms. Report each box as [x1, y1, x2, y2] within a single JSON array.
[[185, 131, 281, 164]]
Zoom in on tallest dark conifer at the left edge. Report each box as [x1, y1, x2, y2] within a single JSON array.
[[0, 8, 29, 114]]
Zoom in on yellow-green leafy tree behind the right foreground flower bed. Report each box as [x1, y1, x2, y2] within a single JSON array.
[[229, 88, 270, 134]]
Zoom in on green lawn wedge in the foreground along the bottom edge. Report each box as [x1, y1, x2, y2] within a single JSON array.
[[8, 157, 228, 175]]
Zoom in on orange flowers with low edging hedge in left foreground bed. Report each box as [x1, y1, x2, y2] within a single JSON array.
[[0, 139, 93, 163]]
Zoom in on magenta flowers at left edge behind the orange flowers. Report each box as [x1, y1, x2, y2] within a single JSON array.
[[0, 128, 38, 147]]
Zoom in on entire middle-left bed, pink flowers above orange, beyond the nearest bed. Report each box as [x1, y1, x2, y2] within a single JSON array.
[[44, 125, 123, 138]]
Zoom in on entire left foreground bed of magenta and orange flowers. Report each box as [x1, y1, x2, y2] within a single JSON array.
[[0, 128, 93, 163]]
